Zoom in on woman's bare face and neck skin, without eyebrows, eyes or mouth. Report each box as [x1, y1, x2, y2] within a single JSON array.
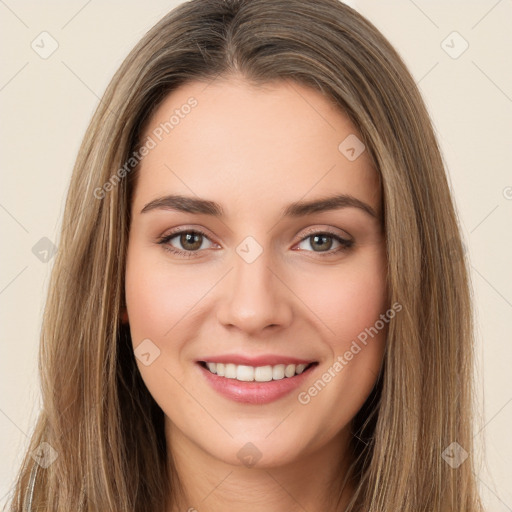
[[126, 77, 389, 512]]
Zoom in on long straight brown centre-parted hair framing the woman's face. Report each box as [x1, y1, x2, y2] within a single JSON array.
[[5, 0, 482, 512]]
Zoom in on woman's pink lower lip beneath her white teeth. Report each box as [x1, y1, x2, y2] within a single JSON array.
[[197, 363, 317, 404]]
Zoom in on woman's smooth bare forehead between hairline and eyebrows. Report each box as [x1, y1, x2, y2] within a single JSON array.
[[135, 79, 380, 216]]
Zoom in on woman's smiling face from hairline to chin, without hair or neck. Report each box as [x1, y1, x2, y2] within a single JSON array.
[[126, 75, 388, 467]]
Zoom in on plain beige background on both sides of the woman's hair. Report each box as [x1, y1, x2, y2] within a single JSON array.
[[0, 0, 512, 512]]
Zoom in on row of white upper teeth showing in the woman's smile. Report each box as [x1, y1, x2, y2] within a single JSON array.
[[202, 363, 308, 382]]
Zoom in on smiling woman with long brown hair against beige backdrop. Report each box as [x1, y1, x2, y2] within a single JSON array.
[[5, 0, 482, 512]]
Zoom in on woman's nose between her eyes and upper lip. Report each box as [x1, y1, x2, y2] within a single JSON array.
[[217, 247, 293, 335]]
